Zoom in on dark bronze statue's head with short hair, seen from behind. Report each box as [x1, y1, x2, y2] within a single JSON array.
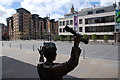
[[42, 42, 57, 61]]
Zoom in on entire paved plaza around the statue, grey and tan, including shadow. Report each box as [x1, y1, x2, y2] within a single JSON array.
[[0, 40, 119, 78]]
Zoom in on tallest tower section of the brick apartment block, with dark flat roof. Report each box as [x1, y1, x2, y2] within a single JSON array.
[[13, 8, 32, 40]]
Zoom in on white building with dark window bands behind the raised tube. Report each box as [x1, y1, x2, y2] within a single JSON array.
[[58, 3, 118, 41]]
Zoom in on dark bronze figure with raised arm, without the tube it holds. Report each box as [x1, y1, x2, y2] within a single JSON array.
[[37, 35, 81, 80]]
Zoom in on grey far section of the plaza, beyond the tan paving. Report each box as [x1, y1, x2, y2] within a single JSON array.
[[3, 40, 120, 60]]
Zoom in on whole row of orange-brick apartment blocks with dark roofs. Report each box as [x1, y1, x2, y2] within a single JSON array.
[[6, 8, 58, 40]]
